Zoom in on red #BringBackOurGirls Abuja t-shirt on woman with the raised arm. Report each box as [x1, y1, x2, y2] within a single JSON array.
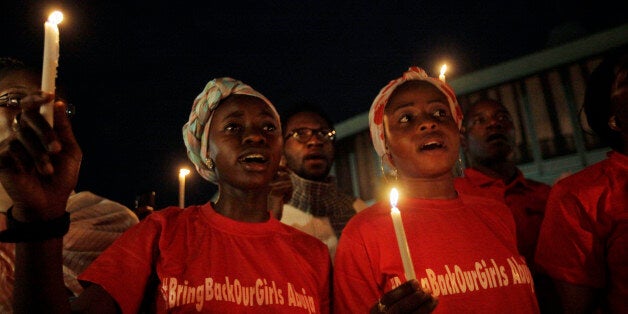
[[79, 204, 331, 313]]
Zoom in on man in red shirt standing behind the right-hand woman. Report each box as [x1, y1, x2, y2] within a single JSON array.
[[454, 98, 556, 311]]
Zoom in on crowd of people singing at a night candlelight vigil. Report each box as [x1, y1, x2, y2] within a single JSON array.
[[0, 45, 628, 313]]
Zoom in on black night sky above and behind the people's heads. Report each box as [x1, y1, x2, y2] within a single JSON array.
[[0, 0, 628, 208]]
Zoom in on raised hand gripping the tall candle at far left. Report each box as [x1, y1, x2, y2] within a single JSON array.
[[0, 98, 82, 220]]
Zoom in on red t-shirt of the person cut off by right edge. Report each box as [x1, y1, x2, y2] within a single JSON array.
[[536, 152, 628, 313]]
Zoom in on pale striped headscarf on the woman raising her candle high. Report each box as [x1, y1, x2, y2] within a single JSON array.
[[183, 77, 279, 183]]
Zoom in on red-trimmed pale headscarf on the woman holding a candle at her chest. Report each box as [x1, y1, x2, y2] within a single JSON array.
[[369, 66, 462, 166]]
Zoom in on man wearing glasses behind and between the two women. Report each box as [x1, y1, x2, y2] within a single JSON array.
[[281, 103, 367, 259]]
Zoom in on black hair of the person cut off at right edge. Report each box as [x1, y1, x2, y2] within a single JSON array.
[[583, 47, 626, 150]]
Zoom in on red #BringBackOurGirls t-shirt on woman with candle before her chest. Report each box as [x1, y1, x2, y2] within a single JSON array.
[[333, 195, 538, 313]]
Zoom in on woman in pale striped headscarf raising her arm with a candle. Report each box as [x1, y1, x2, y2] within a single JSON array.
[[0, 77, 331, 313]]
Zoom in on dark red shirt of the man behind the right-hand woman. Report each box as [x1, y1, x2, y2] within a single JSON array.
[[454, 168, 551, 265]]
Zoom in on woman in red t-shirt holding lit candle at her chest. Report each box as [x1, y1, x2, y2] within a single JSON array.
[[333, 67, 538, 313]]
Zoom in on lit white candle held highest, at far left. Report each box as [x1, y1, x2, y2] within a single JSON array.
[[40, 11, 63, 126]]
